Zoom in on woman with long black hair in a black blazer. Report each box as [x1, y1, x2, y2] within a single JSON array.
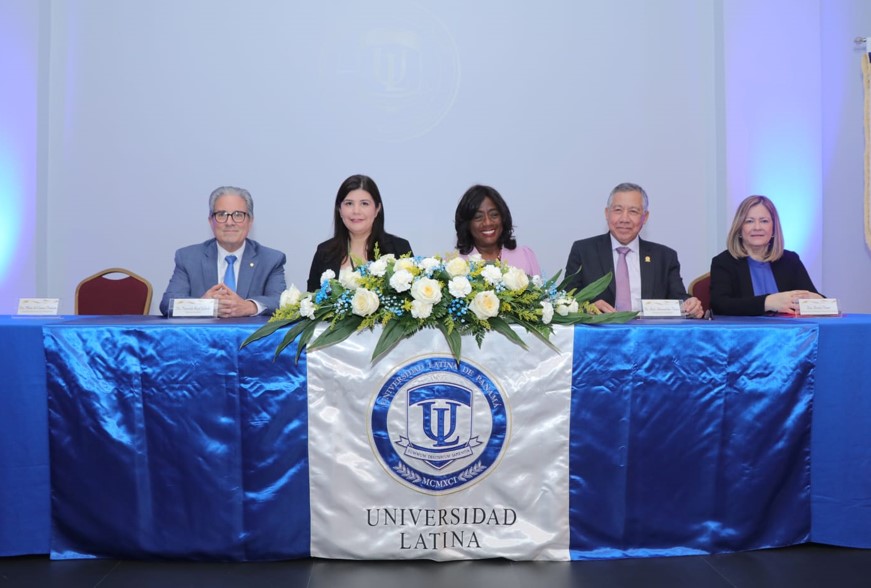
[[307, 174, 412, 292]]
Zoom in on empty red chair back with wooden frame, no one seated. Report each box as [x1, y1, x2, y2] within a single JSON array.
[[76, 267, 151, 314]]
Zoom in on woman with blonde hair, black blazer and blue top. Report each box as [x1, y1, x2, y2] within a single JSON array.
[[711, 196, 822, 316]]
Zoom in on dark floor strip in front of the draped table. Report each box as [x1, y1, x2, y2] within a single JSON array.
[[0, 544, 871, 588]]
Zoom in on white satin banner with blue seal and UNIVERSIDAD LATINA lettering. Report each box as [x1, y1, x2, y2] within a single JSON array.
[[308, 329, 572, 560]]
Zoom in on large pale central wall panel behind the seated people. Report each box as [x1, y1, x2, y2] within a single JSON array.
[[37, 0, 717, 312]]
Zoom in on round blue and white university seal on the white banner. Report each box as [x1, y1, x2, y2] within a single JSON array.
[[369, 357, 510, 494]]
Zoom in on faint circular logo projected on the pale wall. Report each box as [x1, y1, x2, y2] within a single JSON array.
[[320, 2, 460, 141]]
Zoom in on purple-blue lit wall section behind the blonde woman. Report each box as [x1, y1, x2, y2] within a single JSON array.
[[723, 0, 823, 284]]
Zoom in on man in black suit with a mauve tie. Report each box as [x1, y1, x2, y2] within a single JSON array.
[[566, 183, 704, 318]]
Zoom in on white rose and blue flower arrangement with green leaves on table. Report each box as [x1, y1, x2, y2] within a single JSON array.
[[242, 255, 636, 362]]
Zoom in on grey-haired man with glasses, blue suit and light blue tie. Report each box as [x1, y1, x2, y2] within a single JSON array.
[[160, 186, 286, 318]]
